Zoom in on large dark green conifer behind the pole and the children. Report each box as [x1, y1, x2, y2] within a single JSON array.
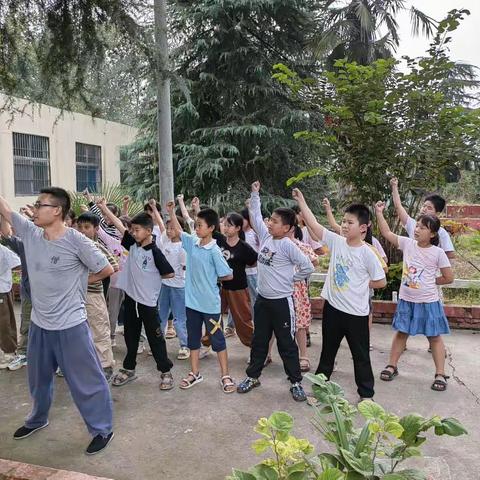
[[122, 0, 328, 210]]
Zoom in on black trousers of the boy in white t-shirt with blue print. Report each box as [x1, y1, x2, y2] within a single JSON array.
[[315, 300, 375, 398]]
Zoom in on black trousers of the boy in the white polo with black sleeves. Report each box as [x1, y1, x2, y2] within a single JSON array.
[[123, 294, 173, 373]]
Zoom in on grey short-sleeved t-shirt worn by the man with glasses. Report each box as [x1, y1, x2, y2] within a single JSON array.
[[12, 213, 108, 330]]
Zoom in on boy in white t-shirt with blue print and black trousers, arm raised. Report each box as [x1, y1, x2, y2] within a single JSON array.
[[293, 189, 387, 399]]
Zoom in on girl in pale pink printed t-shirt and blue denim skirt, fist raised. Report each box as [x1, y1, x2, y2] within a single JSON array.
[[375, 202, 453, 391]]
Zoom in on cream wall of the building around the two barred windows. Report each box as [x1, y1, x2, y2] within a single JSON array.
[[0, 96, 137, 209]]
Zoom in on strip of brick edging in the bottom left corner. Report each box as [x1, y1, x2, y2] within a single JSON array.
[[0, 458, 113, 480]]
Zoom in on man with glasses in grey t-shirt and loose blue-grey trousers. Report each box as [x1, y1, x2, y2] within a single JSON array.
[[0, 187, 113, 454]]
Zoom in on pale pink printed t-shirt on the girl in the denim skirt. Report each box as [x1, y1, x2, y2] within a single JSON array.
[[398, 236, 450, 303]]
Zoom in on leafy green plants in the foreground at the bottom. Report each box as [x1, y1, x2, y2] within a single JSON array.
[[227, 374, 467, 480]]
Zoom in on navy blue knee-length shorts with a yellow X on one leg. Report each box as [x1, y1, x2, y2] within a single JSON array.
[[187, 307, 227, 352]]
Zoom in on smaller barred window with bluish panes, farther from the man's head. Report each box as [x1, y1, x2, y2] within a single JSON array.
[[75, 142, 102, 192]]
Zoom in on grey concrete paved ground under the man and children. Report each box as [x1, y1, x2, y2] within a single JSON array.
[[0, 306, 480, 480]]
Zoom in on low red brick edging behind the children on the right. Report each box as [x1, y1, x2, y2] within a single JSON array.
[[311, 298, 480, 331]]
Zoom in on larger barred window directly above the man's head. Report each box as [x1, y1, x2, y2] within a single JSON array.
[[13, 132, 50, 196]]
